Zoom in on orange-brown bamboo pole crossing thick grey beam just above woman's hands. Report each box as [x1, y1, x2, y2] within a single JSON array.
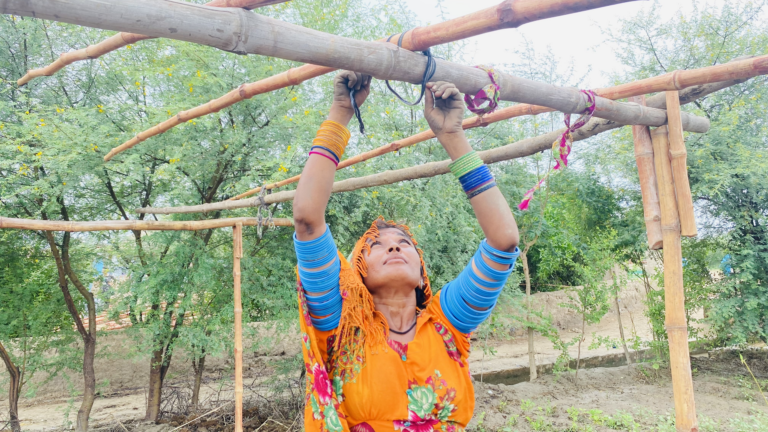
[[104, 0, 637, 162]]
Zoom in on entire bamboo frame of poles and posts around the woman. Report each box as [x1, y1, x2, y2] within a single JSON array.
[[0, 0, 768, 432]]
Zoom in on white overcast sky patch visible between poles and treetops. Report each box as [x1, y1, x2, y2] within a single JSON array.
[[409, 0, 727, 88]]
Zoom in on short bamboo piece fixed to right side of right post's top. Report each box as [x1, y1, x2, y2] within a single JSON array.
[[666, 90, 696, 237]]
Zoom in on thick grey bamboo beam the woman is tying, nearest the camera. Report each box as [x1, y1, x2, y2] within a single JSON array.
[[0, 0, 709, 159]]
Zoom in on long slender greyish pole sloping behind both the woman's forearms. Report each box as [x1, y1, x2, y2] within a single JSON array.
[[135, 80, 744, 214]]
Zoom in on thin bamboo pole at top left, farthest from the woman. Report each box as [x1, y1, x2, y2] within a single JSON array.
[[16, 0, 288, 87]]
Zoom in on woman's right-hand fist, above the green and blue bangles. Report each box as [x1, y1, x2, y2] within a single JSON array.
[[424, 81, 465, 142]]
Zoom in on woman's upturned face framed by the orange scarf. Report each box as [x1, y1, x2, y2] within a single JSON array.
[[363, 228, 422, 293]]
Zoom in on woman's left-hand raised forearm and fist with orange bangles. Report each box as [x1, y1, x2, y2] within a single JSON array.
[[293, 71, 371, 241]]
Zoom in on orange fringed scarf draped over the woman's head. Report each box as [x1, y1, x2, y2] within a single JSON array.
[[329, 216, 432, 382]]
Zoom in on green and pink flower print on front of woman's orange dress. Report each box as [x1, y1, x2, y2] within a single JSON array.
[[394, 371, 461, 432]]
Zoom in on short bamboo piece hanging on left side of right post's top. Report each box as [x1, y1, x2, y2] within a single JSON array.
[[629, 96, 663, 250]]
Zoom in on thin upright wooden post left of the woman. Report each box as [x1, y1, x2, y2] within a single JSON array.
[[232, 222, 243, 432]]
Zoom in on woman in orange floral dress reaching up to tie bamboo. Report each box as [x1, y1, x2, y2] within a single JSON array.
[[293, 71, 519, 432]]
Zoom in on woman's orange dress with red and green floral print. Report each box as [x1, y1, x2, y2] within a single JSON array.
[[298, 256, 475, 432]]
